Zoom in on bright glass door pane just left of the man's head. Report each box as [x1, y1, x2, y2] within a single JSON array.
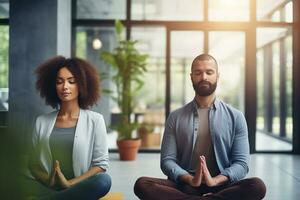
[[170, 31, 204, 111]]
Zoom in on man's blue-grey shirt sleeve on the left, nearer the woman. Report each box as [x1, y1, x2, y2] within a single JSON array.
[[160, 114, 188, 182]]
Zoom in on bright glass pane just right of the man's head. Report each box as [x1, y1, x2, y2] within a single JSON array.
[[209, 31, 245, 111]]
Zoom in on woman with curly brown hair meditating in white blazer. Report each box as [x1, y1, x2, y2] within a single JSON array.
[[25, 56, 111, 199]]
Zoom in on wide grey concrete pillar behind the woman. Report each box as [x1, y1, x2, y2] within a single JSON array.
[[8, 0, 71, 147]]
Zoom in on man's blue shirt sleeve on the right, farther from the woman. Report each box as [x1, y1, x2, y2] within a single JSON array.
[[221, 113, 250, 182]]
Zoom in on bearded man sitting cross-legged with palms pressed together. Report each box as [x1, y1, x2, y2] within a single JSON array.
[[134, 54, 266, 200]]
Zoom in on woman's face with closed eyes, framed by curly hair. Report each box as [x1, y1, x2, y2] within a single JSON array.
[[56, 67, 79, 102]]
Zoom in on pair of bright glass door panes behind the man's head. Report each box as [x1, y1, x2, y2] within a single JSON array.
[[170, 31, 245, 111]]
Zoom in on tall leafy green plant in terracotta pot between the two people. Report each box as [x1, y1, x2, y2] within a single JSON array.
[[101, 20, 148, 160]]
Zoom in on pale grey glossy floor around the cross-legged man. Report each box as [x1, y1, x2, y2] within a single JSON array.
[[109, 153, 300, 200]]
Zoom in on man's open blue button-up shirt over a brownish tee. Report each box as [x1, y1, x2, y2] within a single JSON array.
[[161, 99, 250, 182]]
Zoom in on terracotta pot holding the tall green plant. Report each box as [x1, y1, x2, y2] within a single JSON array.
[[117, 139, 141, 160]]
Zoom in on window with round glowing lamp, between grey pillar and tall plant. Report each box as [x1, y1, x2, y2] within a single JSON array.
[[76, 26, 116, 133]]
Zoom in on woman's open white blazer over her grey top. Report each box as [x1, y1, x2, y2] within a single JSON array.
[[31, 109, 108, 177]]
